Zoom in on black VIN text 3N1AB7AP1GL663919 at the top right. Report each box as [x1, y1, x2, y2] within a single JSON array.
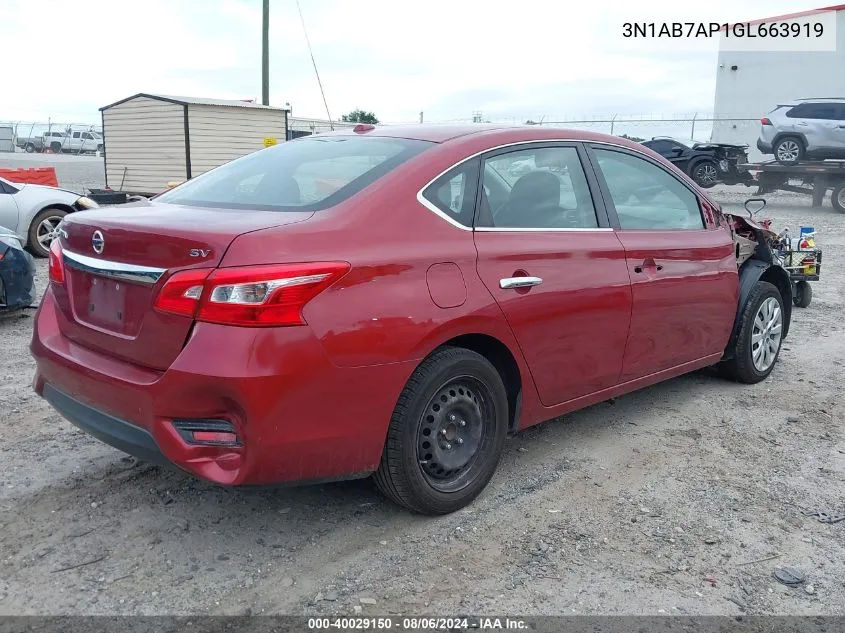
[[622, 22, 824, 39]]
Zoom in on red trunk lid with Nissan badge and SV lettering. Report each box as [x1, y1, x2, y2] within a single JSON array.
[[53, 202, 313, 369]]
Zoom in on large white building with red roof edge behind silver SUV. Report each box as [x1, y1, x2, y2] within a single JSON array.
[[711, 4, 845, 160]]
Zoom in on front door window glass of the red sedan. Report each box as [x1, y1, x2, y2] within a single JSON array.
[[595, 149, 704, 230]]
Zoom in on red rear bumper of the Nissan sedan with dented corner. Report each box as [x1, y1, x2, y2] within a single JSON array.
[[30, 290, 416, 485]]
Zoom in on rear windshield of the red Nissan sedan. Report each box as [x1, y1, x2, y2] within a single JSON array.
[[157, 136, 432, 211]]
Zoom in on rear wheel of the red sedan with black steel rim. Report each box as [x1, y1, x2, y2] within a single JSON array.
[[374, 347, 508, 515]]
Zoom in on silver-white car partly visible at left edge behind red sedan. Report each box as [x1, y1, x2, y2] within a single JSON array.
[[0, 178, 98, 257]]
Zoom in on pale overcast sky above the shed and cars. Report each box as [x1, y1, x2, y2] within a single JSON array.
[[0, 0, 830, 133]]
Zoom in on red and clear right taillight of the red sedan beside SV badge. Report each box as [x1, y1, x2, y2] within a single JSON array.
[[156, 262, 349, 327]]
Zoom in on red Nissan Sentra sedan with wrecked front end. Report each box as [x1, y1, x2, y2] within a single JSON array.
[[31, 124, 792, 514]]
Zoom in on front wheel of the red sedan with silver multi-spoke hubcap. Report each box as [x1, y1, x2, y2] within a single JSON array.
[[719, 281, 785, 384]]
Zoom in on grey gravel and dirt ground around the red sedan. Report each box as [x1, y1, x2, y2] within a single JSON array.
[[0, 184, 845, 615]]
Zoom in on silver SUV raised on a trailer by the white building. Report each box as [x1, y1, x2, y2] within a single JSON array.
[[757, 98, 845, 165]]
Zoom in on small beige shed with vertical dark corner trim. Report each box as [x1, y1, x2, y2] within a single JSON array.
[[100, 93, 288, 194]]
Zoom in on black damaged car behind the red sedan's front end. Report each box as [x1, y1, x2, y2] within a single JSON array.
[[643, 137, 753, 188]]
